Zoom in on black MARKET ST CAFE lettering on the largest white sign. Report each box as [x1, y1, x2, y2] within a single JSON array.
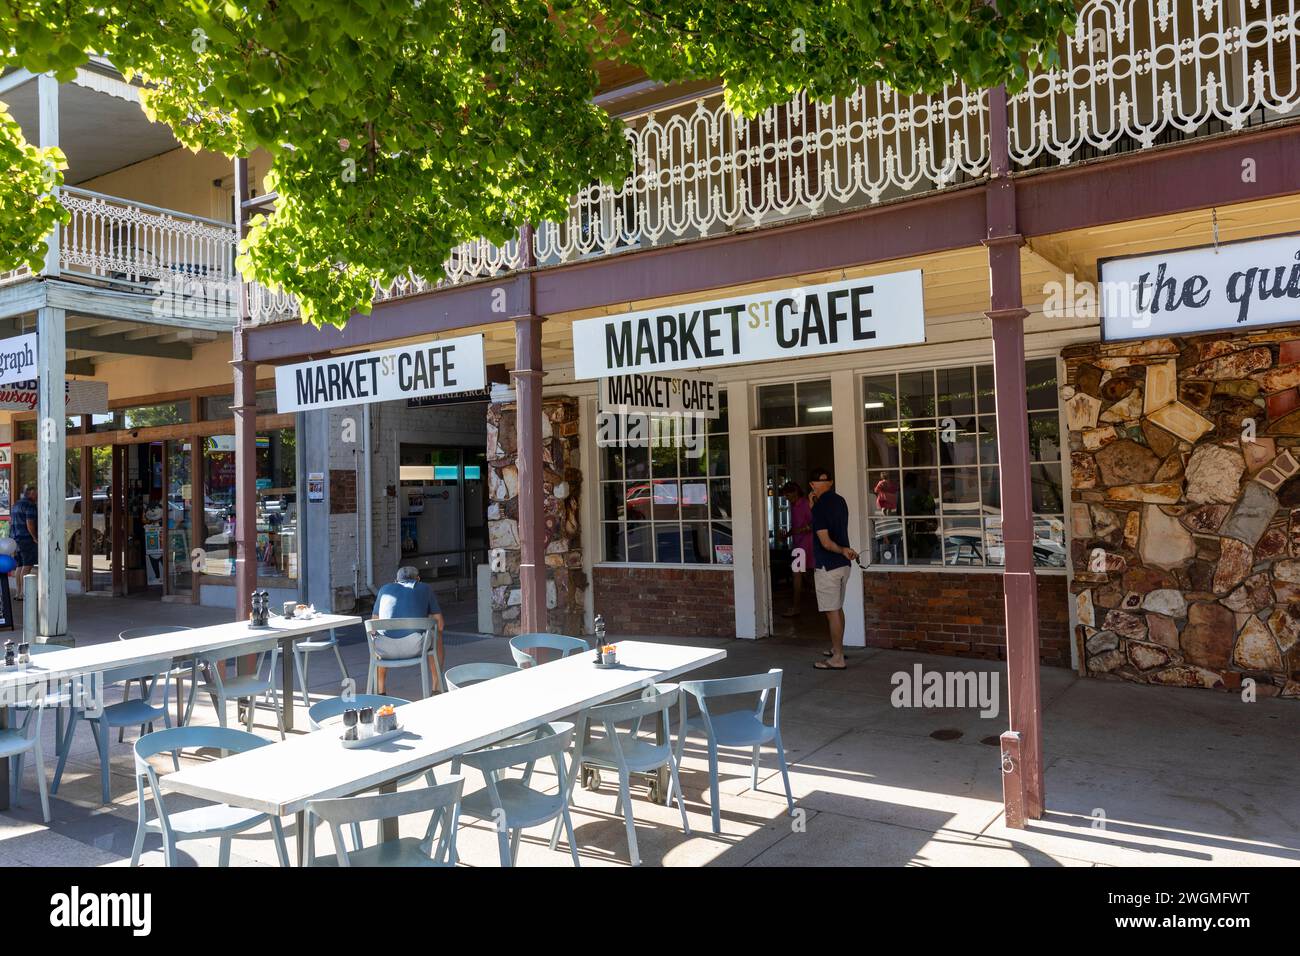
[[605, 285, 876, 368]]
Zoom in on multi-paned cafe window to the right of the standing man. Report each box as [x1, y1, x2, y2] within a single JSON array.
[[863, 359, 1066, 567]]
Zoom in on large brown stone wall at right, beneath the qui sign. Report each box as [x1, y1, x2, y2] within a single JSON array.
[[1062, 329, 1300, 697]]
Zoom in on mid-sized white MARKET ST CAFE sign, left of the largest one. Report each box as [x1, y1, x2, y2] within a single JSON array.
[[276, 334, 485, 412]]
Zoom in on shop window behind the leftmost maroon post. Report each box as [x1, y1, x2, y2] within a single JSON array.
[[203, 428, 298, 587]]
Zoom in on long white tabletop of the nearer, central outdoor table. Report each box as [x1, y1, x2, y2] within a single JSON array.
[[161, 641, 727, 816]]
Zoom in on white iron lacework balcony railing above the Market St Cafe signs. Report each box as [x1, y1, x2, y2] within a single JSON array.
[[239, 0, 1300, 321]]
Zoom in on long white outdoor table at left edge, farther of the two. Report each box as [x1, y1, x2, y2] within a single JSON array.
[[0, 614, 361, 810]]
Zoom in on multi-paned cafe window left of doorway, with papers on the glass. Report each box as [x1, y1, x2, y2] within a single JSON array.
[[599, 392, 732, 564]]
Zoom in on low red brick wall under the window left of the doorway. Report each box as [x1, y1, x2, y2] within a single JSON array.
[[592, 567, 736, 637]]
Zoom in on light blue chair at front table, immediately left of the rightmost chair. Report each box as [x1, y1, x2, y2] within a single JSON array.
[[551, 684, 690, 866]]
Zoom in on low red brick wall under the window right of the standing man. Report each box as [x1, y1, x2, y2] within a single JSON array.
[[862, 571, 1070, 667]]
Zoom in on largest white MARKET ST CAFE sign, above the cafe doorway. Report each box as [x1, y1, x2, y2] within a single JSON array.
[[573, 269, 926, 378]]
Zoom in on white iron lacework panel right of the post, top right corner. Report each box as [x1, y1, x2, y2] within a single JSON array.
[[1010, 0, 1300, 166]]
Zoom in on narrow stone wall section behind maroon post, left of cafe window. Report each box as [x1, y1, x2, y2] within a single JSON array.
[[488, 397, 586, 635]]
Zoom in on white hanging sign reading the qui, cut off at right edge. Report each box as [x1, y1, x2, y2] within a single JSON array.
[[1099, 235, 1300, 341]]
